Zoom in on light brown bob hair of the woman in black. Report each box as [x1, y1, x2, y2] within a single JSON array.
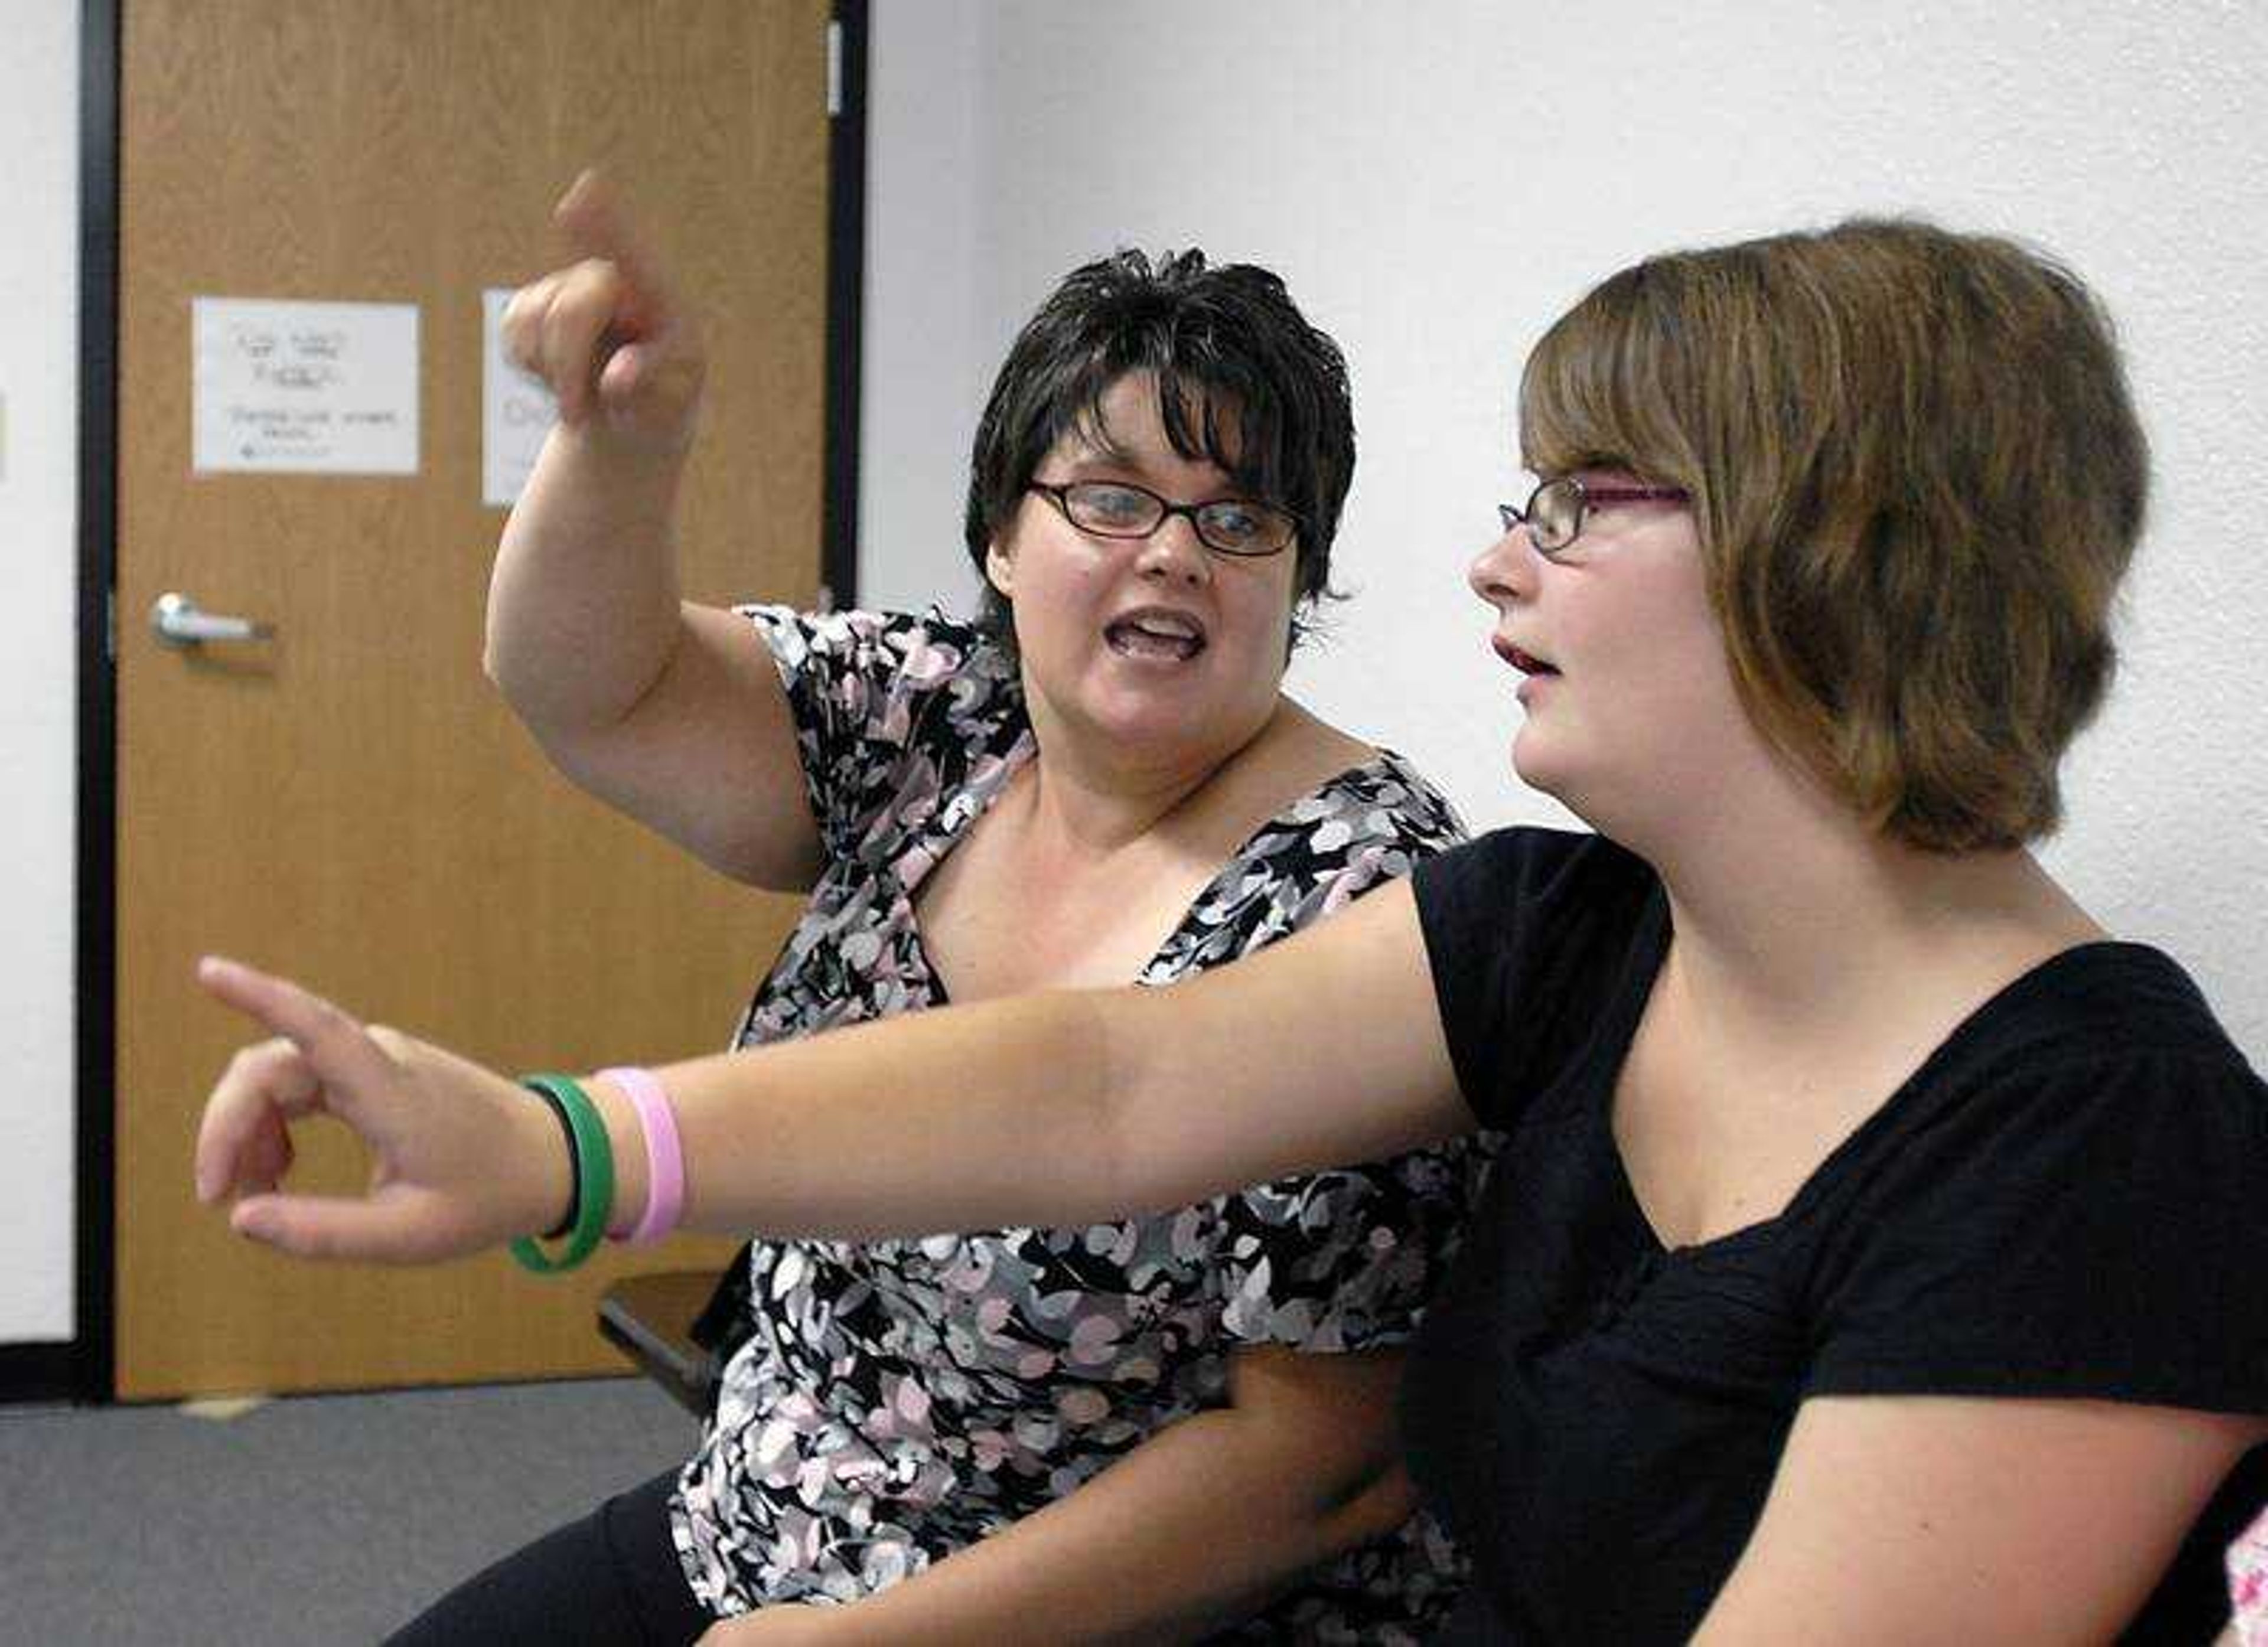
[[1520, 220, 2148, 851]]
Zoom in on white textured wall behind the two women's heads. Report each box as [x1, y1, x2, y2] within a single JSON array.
[[862, 0, 2268, 1067]]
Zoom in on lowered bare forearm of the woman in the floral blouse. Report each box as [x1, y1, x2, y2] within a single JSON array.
[[812, 1409, 1413, 1647]]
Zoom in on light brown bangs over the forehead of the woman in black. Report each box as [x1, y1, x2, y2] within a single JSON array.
[[1520, 263, 1701, 493]]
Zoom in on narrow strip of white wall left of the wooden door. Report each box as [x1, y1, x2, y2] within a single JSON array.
[[0, 0, 79, 1343]]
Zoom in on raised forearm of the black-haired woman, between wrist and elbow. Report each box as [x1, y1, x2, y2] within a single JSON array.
[[485, 422, 685, 735]]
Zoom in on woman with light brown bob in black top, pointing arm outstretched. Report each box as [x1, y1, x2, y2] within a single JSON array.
[[197, 222, 2268, 1642]]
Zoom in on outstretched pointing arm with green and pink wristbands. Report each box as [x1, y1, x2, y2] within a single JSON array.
[[197, 882, 1472, 1264]]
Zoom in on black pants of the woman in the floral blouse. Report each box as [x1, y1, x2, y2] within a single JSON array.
[[390, 1470, 716, 1647]]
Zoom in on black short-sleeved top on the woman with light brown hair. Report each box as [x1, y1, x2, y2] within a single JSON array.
[[1402, 830, 2268, 1642]]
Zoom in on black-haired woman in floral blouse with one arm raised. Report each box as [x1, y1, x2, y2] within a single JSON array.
[[367, 179, 1479, 1642]]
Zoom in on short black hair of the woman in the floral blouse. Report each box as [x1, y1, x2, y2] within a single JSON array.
[[966, 250, 1354, 651]]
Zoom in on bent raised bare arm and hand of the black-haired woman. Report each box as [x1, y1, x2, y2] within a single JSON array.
[[485, 172, 819, 889]]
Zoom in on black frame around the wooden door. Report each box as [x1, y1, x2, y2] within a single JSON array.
[[37, 0, 869, 1404]]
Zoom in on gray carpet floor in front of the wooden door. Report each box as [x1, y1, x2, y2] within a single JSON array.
[[0, 1379, 696, 1647]]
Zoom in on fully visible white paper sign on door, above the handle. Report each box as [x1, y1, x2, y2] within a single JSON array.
[[191, 297, 418, 474]]
